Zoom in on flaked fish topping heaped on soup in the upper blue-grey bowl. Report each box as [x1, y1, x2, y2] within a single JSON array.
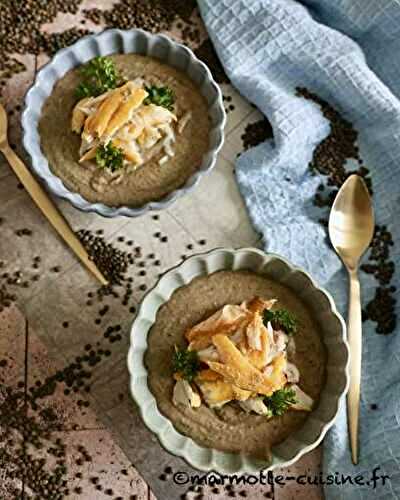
[[71, 78, 191, 171]]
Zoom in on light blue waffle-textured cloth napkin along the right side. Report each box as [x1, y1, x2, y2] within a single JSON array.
[[199, 0, 400, 500]]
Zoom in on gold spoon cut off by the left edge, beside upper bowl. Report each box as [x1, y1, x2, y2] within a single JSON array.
[[0, 103, 108, 285]]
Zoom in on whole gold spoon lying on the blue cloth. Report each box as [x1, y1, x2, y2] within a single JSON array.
[[329, 175, 375, 464]]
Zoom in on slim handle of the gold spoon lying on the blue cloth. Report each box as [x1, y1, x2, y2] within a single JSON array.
[[347, 269, 362, 465]]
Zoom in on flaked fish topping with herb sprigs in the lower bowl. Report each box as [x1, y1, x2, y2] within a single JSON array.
[[173, 297, 313, 418]]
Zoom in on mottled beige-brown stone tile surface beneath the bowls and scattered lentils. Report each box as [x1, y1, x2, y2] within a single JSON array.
[[0, 0, 322, 500]]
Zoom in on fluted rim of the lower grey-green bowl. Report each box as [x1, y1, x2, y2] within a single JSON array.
[[127, 247, 350, 474]]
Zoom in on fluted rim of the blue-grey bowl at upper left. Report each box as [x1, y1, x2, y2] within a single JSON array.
[[21, 28, 226, 217]]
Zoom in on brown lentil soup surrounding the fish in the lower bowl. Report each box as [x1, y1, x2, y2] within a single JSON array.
[[145, 271, 326, 459]]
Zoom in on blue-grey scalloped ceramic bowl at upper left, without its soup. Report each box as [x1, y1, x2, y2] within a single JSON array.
[[22, 29, 225, 217]]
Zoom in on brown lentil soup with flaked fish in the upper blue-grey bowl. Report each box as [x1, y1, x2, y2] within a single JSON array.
[[39, 54, 210, 206]]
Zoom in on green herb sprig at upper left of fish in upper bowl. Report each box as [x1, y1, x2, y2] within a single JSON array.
[[75, 56, 121, 99]]
